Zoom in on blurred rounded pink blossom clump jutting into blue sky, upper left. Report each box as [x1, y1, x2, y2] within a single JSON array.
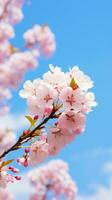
[[24, 25, 56, 56]]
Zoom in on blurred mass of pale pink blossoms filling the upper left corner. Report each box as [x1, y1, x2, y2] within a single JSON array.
[[0, 0, 56, 115]]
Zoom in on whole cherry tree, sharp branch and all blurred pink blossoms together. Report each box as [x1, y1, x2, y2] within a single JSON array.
[[0, 0, 97, 200]]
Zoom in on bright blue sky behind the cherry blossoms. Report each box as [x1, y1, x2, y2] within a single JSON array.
[[6, 0, 112, 200]]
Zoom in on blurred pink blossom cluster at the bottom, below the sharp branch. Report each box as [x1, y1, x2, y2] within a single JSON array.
[[28, 160, 77, 200]]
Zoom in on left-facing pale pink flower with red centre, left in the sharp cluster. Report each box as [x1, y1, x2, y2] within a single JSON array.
[[25, 82, 57, 117]]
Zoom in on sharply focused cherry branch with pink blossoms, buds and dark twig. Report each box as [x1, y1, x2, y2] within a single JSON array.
[[0, 65, 97, 187]]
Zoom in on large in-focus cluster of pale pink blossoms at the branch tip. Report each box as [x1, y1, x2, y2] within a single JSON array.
[[20, 65, 97, 165]]
